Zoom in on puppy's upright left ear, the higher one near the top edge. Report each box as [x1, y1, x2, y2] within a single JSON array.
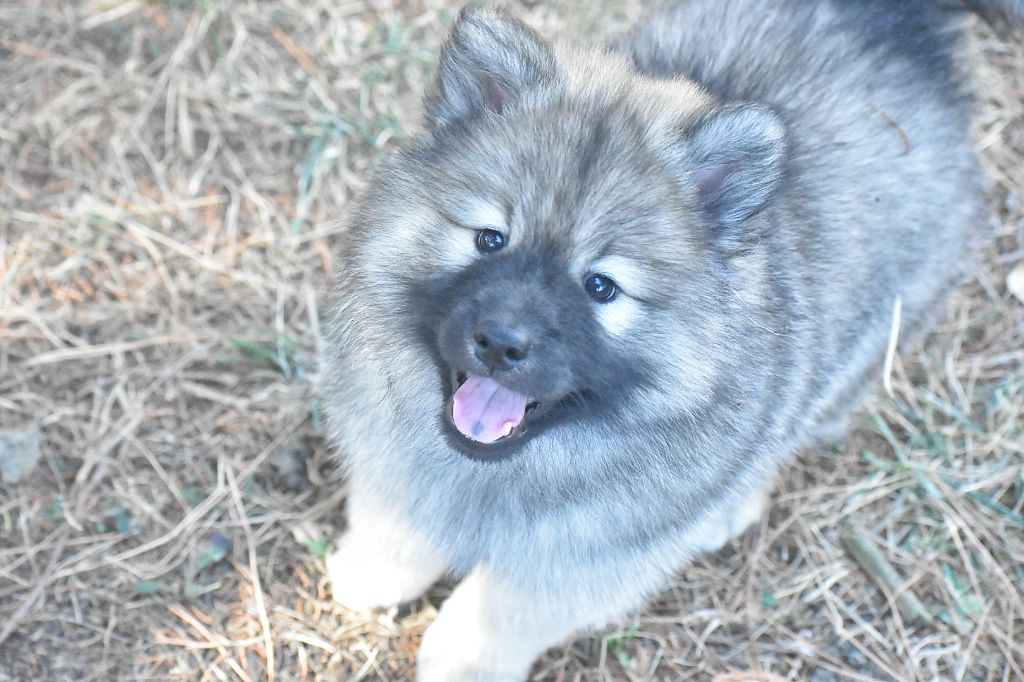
[[426, 7, 555, 128]]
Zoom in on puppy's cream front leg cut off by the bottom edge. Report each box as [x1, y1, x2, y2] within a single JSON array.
[[417, 565, 655, 682]]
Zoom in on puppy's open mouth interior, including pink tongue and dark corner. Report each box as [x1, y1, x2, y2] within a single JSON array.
[[446, 371, 543, 445]]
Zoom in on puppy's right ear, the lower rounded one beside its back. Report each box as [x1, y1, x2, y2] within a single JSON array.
[[685, 104, 786, 225]]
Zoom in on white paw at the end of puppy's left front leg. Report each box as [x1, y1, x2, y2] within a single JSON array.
[[327, 538, 439, 613]]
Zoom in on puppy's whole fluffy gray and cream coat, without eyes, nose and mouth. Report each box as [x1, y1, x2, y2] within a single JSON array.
[[324, 0, 999, 680]]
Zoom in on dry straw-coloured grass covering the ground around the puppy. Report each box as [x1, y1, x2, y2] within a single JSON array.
[[0, 0, 1024, 682]]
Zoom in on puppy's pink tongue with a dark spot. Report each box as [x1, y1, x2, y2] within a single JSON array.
[[452, 376, 527, 443]]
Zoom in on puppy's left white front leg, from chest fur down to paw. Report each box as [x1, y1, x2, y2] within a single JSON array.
[[327, 491, 447, 612]]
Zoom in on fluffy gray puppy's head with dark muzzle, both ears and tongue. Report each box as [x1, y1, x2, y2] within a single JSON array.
[[344, 11, 784, 454]]
